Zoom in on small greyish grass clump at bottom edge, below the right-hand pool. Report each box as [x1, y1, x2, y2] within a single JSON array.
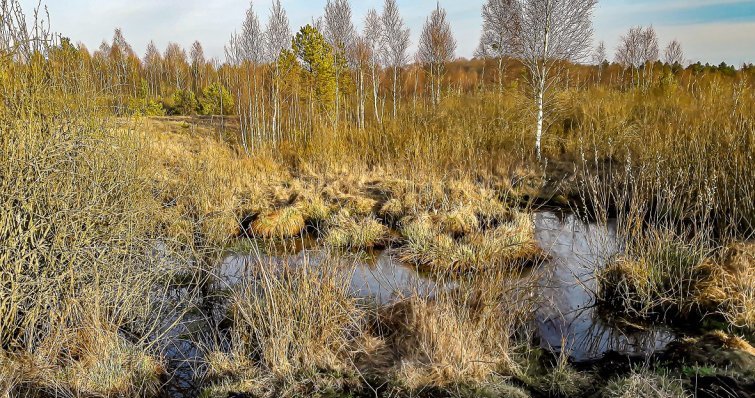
[[603, 369, 691, 398]]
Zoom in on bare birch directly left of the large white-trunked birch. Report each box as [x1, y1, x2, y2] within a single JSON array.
[[476, 0, 522, 91]]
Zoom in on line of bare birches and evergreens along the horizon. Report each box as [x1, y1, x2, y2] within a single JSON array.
[[5, 0, 752, 154]]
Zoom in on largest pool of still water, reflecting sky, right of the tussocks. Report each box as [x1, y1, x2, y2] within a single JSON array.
[[535, 213, 675, 361]]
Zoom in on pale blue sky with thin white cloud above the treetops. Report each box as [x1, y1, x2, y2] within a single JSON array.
[[21, 0, 755, 65]]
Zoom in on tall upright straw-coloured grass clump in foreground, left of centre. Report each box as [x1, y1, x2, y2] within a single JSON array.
[[213, 262, 364, 395]]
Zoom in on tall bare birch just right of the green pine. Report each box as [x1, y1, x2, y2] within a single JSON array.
[[323, 0, 356, 124]]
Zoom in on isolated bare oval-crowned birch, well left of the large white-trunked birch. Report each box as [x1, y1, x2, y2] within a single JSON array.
[[418, 3, 456, 105]]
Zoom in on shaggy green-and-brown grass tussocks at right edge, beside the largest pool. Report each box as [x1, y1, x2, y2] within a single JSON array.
[[598, 231, 755, 330]]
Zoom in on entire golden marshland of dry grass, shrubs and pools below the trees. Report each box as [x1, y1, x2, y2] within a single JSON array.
[[0, 2, 755, 397]]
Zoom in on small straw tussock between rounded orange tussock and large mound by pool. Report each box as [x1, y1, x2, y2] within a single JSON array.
[[324, 210, 389, 249]]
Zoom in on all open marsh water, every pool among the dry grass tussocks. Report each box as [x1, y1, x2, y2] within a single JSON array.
[[165, 212, 676, 397]]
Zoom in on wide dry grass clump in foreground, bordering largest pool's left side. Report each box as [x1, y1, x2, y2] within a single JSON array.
[[379, 273, 534, 391]]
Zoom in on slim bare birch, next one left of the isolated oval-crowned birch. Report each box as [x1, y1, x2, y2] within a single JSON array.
[[381, 0, 411, 118]]
